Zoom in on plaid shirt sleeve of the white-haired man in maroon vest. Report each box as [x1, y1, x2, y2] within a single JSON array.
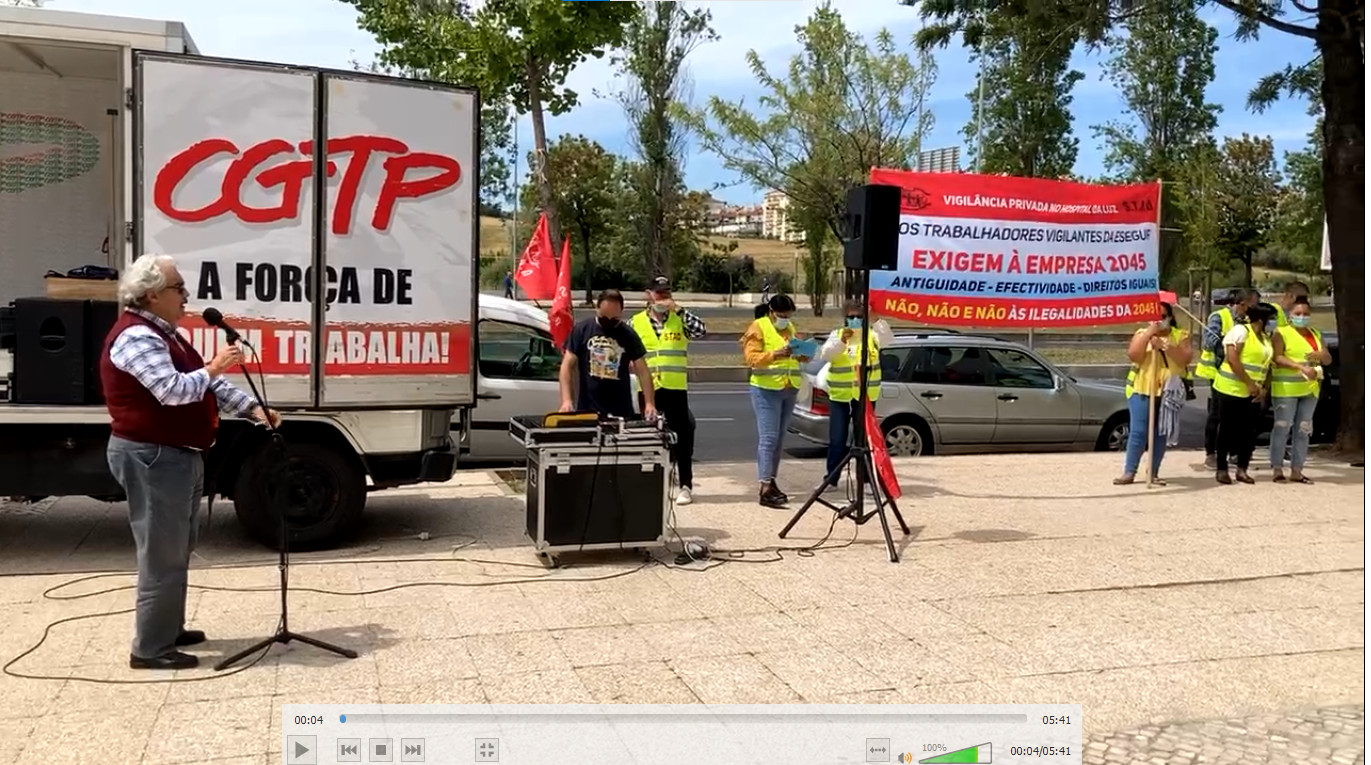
[[110, 308, 256, 417]]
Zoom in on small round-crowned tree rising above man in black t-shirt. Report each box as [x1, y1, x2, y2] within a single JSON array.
[[520, 136, 622, 303]]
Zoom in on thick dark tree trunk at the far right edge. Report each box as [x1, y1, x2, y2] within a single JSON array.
[[1319, 11, 1367, 455]]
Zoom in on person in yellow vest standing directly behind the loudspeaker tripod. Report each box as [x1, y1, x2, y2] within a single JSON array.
[[816, 299, 894, 488]]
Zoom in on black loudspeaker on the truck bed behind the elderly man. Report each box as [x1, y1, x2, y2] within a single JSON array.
[[10, 298, 119, 406]]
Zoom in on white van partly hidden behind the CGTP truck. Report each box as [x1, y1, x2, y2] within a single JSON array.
[[466, 295, 562, 463]]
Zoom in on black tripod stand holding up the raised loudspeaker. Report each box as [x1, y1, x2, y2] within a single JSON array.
[[780, 269, 909, 563]]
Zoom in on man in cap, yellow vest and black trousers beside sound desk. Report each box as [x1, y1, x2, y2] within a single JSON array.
[[632, 276, 705, 505]]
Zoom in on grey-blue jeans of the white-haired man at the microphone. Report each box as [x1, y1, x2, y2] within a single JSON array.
[[106, 436, 204, 658]]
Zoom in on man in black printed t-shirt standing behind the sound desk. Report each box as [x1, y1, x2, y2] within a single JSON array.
[[559, 289, 657, 420]]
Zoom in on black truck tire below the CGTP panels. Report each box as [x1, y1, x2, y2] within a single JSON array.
[[233, 441, 366, 553]]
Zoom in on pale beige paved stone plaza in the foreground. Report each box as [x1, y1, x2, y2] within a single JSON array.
[[0, 454, 1366, 765]]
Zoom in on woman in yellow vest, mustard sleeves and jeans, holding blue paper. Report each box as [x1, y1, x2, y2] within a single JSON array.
[[742, 295, 809, 509]]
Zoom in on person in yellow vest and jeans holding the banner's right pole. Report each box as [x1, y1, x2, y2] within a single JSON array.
[[1113, 303, 1194, 485]]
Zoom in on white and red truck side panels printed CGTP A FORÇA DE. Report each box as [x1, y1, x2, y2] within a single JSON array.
[[140, 60, 477, 403]]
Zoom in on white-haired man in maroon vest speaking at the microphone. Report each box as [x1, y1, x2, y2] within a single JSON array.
[[100, 255, 280, 669]]
